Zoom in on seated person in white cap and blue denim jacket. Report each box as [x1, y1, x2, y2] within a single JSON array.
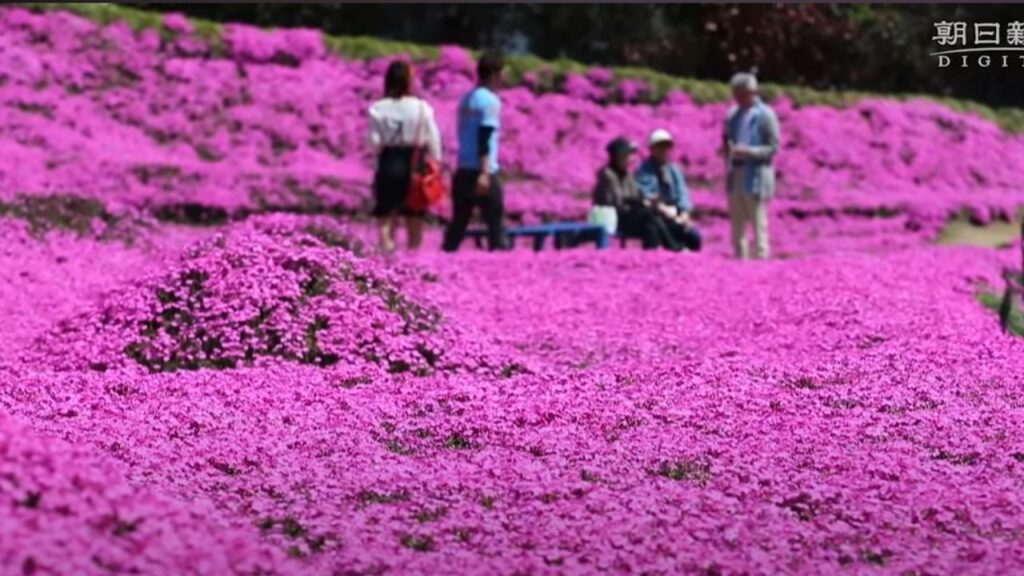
[[635, 128, 701, 252]]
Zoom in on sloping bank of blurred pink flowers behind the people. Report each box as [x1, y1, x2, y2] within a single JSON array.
[[0, 3, 1024, 239]]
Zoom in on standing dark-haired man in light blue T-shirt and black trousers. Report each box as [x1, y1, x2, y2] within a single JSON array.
[[443, 52, 506, 252]]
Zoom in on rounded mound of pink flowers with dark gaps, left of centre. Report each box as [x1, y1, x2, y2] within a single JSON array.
[[29, 213, 503, 375]]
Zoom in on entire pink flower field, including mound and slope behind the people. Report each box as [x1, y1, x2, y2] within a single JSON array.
[[0, 7, 1024, 576]]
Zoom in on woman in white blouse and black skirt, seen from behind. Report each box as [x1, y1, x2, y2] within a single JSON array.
[[370, 60, 441, 251]]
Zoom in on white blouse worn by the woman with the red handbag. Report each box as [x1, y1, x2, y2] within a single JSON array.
[[370, 96, 441, 162]]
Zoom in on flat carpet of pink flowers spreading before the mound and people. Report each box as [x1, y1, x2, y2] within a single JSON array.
[[0, 233, 1024, 574]]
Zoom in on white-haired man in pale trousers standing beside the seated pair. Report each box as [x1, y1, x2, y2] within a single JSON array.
[[723, 73, 778, 259]]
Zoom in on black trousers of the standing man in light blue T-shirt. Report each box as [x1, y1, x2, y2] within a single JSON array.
[[442, 168, 507, 252]]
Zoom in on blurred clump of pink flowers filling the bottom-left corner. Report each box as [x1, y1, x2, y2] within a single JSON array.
[[0, 408, 284, 574]]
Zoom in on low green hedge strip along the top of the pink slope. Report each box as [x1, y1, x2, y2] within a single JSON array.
[[23, 3, 1024, 133]]
